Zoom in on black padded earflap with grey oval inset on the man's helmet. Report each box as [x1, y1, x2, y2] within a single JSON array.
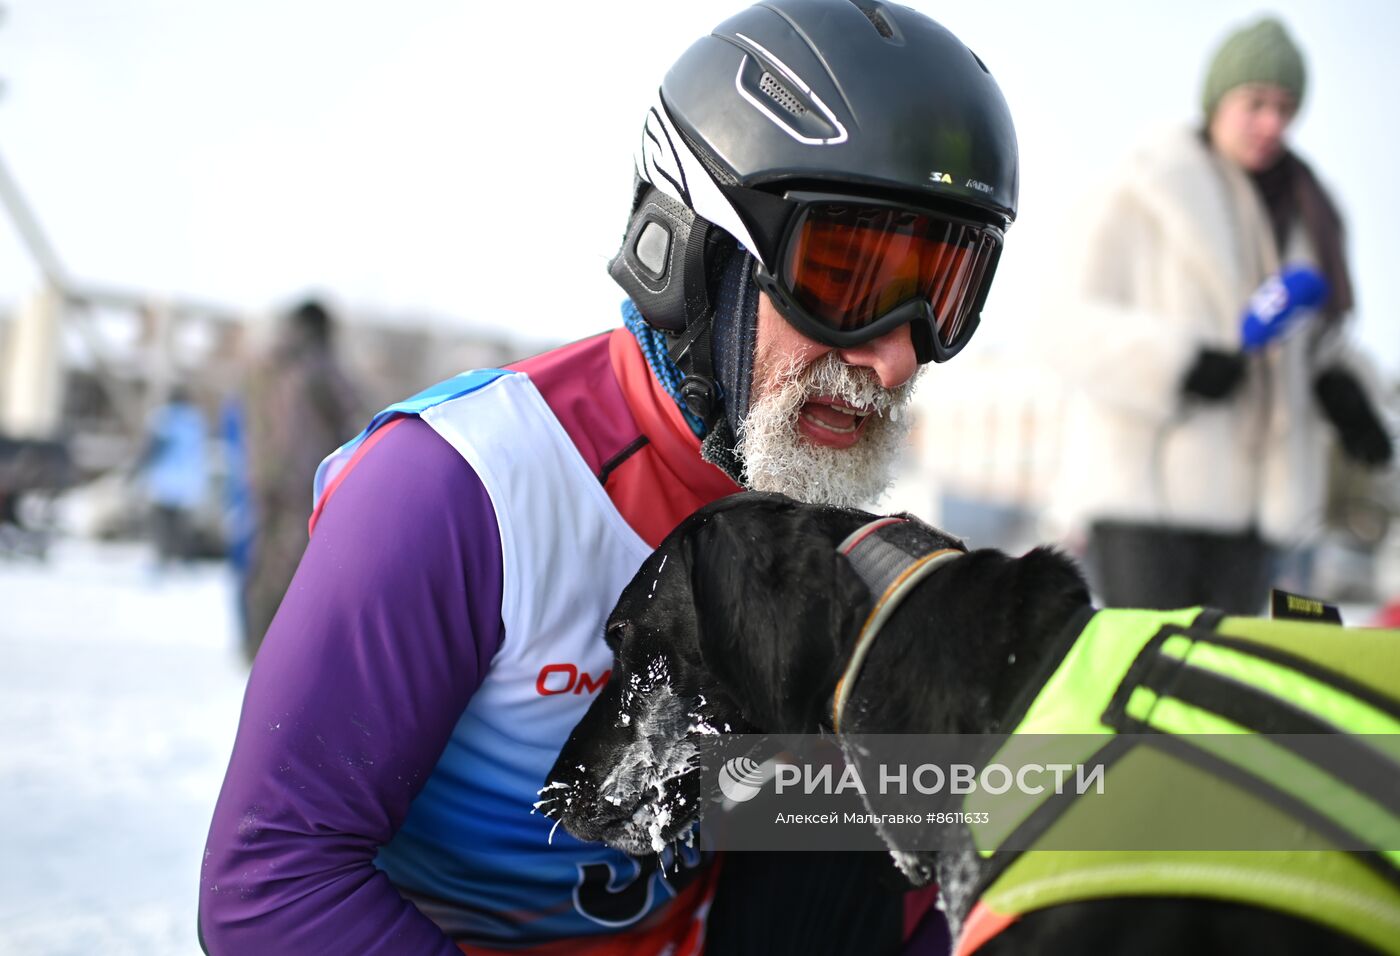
[[608, 185, 696, 332]]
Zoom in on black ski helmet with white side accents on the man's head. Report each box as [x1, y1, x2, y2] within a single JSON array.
[[609, 0, 1019, 419]]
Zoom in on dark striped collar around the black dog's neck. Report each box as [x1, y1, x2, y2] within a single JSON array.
[[832, 516, 967, 732]]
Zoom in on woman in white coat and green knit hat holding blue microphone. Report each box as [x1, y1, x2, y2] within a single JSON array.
[[1046, 17, 1392, 613]]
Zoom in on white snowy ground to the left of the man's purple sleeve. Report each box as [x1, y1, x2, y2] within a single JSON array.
[[0, 542, 246, 956]]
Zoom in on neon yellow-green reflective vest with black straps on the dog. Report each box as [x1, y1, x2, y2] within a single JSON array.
[[955, 610, 1400, 956]]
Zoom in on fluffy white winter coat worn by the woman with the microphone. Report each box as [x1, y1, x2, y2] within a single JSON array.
[[1044, 129, 1375, 543]]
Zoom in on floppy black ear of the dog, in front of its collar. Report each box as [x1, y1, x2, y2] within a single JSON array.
[[692, 501, 869, 732]]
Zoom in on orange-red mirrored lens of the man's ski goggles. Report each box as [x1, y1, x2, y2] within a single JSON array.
[[784, 203, 1000, 346]]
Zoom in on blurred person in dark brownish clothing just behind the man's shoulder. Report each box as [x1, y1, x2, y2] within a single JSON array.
[[242, 298, 364, 661]]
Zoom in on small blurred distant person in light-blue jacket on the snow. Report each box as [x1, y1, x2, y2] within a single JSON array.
[[141, 385, 209, 568]]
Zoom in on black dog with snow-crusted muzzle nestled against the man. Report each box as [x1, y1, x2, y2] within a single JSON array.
[[540, 494, 1394, 956]]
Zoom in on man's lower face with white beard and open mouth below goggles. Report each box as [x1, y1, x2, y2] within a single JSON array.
[[738, 295, 918, 507]]
